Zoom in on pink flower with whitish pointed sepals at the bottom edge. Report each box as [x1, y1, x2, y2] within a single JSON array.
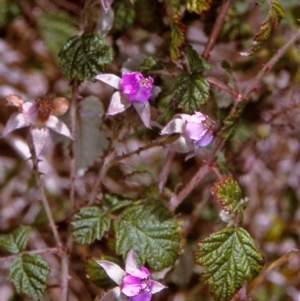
[[96, 250, 165, 301]]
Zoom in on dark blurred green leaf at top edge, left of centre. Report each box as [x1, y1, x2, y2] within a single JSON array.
[[113, 0, 135, 31]]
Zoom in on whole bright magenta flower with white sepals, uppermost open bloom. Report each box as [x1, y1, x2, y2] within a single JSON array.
[[95, 72, 153, 127]]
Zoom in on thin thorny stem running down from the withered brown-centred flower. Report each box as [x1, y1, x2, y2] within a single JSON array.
[[28, 132, 62, 247]]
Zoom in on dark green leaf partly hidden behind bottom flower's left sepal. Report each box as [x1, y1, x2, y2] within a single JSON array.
[[84, 256, 121, 290]]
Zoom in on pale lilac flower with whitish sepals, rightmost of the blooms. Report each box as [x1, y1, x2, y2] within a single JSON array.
[[161, 112, 215, 153]]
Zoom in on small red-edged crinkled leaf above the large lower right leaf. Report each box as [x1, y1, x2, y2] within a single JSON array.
[[211, 176, 242, 213]]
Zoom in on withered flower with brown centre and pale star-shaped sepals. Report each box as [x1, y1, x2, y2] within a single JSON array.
[[2, 94, 73, 156]]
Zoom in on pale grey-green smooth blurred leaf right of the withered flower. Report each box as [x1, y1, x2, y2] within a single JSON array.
[[75, 96, 109, 169]]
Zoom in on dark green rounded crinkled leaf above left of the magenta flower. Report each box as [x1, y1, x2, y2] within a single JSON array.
[[59, 32, 113, 80]]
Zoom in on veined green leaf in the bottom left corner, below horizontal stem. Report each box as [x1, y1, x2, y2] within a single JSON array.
[[9, 254, 50, 299]]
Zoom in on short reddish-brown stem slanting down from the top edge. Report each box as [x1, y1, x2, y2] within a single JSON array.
[[202, 0, 232, 60]]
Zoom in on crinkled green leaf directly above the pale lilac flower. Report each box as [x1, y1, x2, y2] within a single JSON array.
[[174, 73, 209, 113]]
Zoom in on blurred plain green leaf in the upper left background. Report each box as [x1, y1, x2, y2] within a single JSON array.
[[37, 10, 76, 56]]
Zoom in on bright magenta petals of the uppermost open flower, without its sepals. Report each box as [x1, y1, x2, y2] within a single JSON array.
[[120, 72, 153, 103]]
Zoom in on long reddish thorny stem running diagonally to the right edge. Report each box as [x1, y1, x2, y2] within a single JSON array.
[[170, 29, 300, 210]]
